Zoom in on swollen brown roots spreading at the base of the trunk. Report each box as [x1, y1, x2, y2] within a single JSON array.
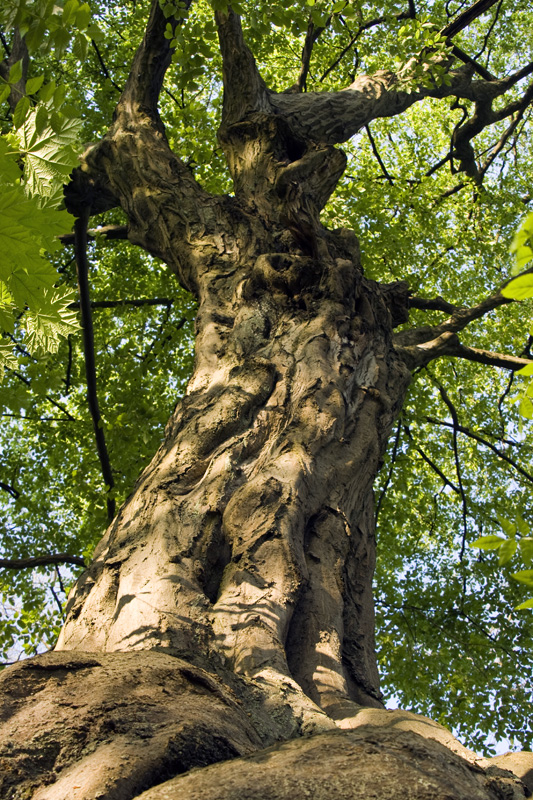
[[0, 651, 531, 800]]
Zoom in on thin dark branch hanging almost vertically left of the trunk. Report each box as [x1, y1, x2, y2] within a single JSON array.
[[74, 209, 115, 522]]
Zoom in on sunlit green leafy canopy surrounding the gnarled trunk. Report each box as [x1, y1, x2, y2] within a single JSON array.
[[0, 0, 533, 750]]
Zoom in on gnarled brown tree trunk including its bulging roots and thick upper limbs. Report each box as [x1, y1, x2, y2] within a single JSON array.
[[0, 2, 525, 800]]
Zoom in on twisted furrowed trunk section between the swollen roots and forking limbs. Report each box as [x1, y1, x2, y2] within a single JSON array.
[[57, 201, 408, 709]]
